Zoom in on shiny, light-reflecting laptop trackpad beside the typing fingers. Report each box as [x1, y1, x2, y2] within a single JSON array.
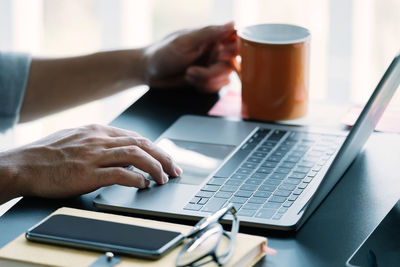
[[157, 138, 235, 185]]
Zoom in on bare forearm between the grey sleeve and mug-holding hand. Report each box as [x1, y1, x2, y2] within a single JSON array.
[[20, 49, 146, 121]]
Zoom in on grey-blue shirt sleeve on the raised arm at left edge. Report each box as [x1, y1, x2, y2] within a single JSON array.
[[0, 52, 31, 131]]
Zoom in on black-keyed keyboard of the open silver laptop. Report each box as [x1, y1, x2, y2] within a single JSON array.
[[184, 128, 344, 220]]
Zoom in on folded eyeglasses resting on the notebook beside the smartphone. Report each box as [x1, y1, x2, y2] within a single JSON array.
[[175, 203, 239, 267]]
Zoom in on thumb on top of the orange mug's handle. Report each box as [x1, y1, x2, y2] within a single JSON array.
[[189, 22, 235, 45]]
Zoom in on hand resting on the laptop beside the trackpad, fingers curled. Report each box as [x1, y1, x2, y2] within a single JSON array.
[[0, 125, 182, 203]]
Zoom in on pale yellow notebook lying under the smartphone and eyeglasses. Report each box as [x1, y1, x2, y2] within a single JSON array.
[[0, 208, 267, 267]]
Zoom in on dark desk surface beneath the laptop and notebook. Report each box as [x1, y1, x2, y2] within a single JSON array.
[[0, 91, 400, 266]]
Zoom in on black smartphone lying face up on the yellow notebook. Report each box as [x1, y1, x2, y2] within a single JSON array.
[[25, 214, 184, 259]]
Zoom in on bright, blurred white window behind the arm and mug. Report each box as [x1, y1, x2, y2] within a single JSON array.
[[0, 0, 400, 142]]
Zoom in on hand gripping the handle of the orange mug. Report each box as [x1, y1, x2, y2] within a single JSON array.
[[144, 23, 238, 92]]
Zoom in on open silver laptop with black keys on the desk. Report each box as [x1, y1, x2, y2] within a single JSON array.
[[94, 54, 400, 231]]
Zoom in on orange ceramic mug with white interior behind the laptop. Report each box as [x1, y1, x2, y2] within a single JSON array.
[[236, 24, 311, 120]]
